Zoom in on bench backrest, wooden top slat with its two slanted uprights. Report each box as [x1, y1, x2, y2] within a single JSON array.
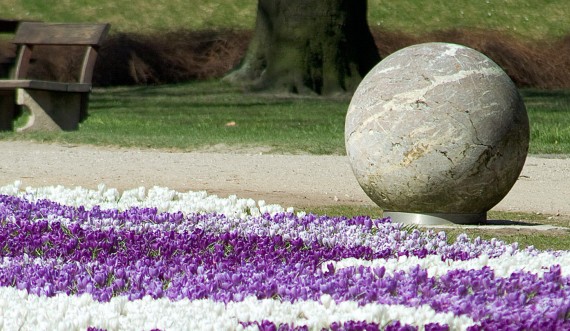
[[12, 22, 110, 83]]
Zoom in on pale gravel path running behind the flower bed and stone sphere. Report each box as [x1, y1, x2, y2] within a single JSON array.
[[0, 141, 570, 218]]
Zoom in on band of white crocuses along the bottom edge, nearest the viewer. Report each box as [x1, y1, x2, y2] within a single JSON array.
[[0, 287, 475, 330]]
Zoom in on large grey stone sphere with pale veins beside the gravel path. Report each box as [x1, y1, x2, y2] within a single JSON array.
[[345, 43, 529, 215]]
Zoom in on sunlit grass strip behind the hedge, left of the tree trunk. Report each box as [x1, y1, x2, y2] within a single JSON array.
[[0, 0, 256, 32]]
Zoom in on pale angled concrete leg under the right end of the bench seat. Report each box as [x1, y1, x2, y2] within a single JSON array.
[[17, 89, 83, 132]]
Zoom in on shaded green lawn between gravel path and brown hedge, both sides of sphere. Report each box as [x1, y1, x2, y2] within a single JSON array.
[[0, 81, 570, 154]]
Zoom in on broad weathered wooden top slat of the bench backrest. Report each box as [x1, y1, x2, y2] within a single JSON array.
[[13, 22, 110, 45]]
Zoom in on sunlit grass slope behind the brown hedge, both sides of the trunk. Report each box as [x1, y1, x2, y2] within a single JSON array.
[[0, 0, 570, 39]]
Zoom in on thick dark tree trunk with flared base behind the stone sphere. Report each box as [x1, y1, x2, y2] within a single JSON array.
[[225, 0, 380, 96]]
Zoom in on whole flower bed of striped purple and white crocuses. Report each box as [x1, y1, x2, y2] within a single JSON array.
[[0, 183, 570, 330]]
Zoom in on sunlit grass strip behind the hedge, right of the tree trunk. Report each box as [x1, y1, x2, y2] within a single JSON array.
[[368, 0, 570, 39]]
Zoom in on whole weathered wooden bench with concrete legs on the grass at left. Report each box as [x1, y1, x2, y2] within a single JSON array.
[[0, 22, 110, 131]]
